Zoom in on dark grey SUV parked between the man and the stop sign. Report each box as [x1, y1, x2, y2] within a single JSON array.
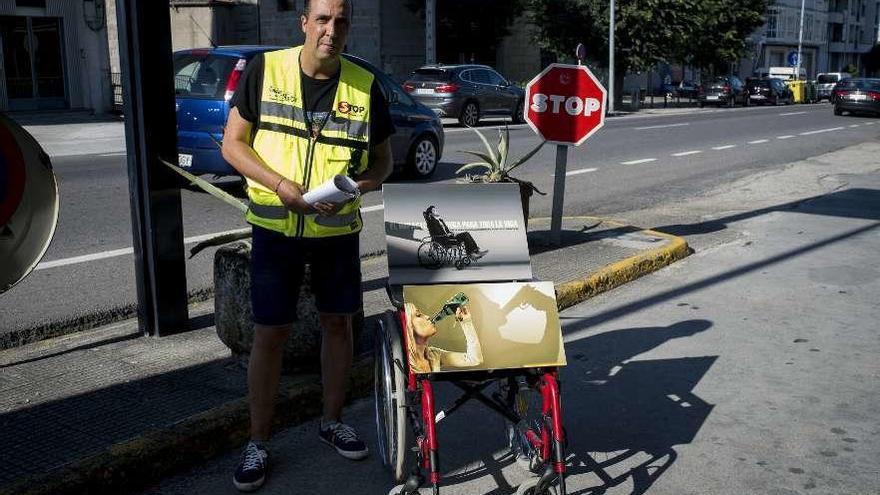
[[403, 65, 525, 127]]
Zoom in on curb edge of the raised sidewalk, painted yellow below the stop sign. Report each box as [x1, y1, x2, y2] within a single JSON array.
[[0, 216, 691, 495]]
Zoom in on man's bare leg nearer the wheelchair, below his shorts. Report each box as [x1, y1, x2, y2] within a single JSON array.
[[320, 313, 353, 422]]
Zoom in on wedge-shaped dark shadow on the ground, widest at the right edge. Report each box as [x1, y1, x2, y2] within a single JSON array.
[[653, 188, 880, 236]]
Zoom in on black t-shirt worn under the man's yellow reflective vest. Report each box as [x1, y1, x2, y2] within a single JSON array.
[[230, 54, 394, 146]]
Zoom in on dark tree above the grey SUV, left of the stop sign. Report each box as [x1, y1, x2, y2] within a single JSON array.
[[406, 0, 523, 65]]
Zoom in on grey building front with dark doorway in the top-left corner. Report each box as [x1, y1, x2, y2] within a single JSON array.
[[0, 0, 111, 113]]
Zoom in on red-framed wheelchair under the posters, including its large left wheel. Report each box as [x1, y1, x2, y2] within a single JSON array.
[[374, 306, 566, 495]]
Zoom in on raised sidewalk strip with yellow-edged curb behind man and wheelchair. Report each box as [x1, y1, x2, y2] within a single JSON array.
[[0, 217, 688, 494]]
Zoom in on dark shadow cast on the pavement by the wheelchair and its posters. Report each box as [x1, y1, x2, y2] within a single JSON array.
[[422, 320, 717, 495]]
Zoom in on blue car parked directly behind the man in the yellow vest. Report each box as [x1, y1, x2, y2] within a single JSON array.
[[174, 45, 444, 178]]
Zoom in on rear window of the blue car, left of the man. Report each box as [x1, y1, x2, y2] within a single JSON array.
[[174, 53, 238, 99]]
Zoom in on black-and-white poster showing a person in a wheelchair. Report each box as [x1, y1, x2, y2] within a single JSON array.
[[382, 184, 532, 285]]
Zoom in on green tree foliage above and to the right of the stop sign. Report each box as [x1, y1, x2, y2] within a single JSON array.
[[525, 0, 768, 72]]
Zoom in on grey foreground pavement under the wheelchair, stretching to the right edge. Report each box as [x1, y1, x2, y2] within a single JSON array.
[[144, 154, 880, 495]]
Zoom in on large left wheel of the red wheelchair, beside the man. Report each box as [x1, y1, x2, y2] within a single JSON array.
[[374, 311, 411, 483]]
